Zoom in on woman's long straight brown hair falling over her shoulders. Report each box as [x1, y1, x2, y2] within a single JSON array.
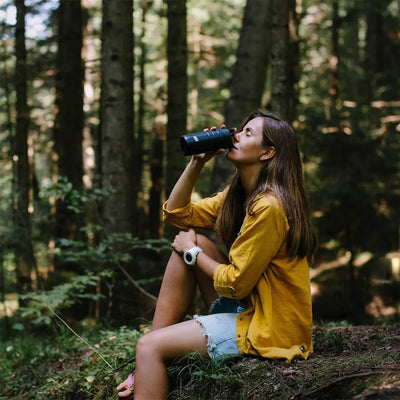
[[216, 110, 317, 262]]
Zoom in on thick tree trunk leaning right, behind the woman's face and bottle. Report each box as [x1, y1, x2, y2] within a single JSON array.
[[211, 0, 272, 192]]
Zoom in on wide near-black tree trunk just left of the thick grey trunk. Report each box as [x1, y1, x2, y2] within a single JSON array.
[[55, 0, 84, 239]]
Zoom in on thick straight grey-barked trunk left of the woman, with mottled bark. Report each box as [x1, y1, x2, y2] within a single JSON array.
[[101, 0, 135, 234]]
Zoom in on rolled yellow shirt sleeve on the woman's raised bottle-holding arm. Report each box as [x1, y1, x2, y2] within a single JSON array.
[[163, 192, 225, 231]]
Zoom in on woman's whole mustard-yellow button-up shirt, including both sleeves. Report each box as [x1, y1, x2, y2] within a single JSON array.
[[163, 192, 312, 362]]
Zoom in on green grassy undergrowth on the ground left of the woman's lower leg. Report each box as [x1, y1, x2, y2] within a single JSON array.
[[0, 326, 141, 400]]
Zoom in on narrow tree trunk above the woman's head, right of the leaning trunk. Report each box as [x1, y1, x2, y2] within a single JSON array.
[[271, 0, 298, 122]]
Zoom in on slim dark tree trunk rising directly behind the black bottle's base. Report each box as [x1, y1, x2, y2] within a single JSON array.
[[164, 0, 188, 237]]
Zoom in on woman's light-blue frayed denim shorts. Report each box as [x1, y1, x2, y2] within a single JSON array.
[[194, 297, 245, 359]]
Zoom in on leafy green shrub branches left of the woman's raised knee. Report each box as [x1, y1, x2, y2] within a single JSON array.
[[13, 234, 170, 331]]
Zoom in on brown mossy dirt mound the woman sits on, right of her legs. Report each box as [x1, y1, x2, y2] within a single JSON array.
[[170, 326, 400, 400]]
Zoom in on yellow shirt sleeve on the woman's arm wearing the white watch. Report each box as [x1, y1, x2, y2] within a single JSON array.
[[214, 196, 289, 299]]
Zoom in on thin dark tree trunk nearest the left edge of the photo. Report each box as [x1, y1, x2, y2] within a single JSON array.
[[14, 0, 35, 303]]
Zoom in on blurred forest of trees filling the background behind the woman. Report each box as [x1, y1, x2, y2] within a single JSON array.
[[0, 0, 400, 321]]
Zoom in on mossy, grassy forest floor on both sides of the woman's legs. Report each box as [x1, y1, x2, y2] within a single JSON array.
[[0, 321, 400, 400]]
